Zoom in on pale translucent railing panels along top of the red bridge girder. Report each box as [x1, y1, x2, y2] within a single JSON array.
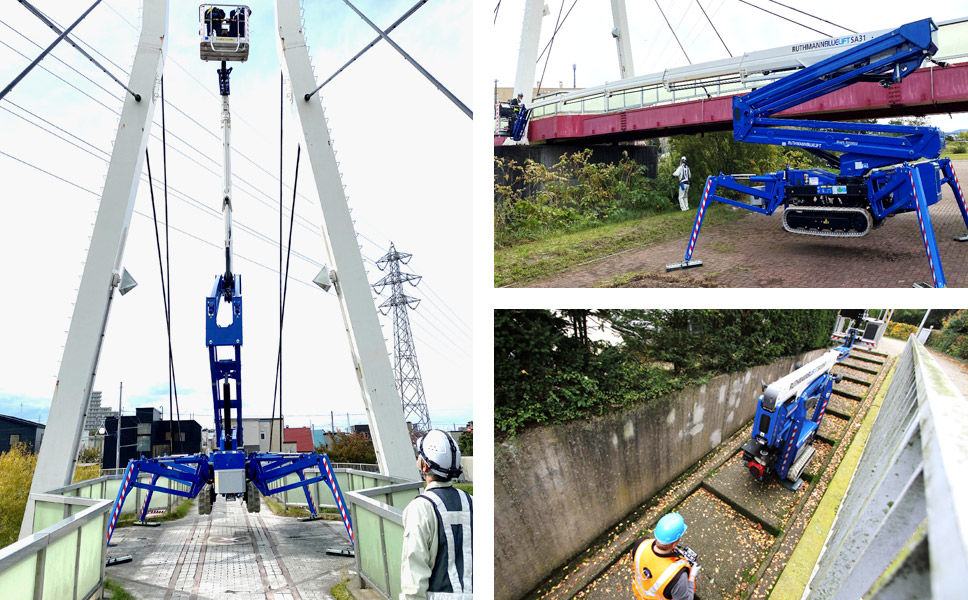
[[528, 17, 968, 120]]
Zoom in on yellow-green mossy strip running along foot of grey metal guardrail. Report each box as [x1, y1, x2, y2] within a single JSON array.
[[770, 363, 897, 598]]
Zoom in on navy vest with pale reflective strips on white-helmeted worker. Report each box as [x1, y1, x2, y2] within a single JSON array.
[[418, 487, 474, 600]]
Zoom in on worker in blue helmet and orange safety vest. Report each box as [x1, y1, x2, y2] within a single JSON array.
[[632, 513, 699, 600]]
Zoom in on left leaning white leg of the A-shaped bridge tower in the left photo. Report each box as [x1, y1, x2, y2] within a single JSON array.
[[20, 0, 168, 539]]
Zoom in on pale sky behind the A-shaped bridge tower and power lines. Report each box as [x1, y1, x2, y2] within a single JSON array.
[[0, 0, 473, 428]]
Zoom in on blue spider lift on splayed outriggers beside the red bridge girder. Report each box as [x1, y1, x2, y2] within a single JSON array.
[[666, 19, 968, 287]]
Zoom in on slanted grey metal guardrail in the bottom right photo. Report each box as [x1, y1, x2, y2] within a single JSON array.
[[808, 336, 968, 599]]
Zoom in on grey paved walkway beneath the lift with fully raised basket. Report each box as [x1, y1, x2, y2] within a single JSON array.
[[106, 498, 356, 600]]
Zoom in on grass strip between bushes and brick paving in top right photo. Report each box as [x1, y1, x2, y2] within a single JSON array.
[[494, 203, 746, 287]]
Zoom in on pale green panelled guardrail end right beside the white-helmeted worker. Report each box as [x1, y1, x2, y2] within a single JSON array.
[[344, 475, 424, 599]]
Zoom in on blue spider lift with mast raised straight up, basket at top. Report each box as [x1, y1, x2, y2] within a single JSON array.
[[107, 5, 354, 548]]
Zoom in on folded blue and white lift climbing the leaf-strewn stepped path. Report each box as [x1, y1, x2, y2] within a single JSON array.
[[743, 327, 857, 490]]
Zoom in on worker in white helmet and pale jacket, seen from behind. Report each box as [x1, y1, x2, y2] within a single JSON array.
[[400, 429, 474, 600]]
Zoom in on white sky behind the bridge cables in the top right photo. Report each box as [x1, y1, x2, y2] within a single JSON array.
[[489, 0, 968, 131]]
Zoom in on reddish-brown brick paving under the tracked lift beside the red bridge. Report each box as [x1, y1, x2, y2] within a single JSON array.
[[533, 160, 968, 287]]
